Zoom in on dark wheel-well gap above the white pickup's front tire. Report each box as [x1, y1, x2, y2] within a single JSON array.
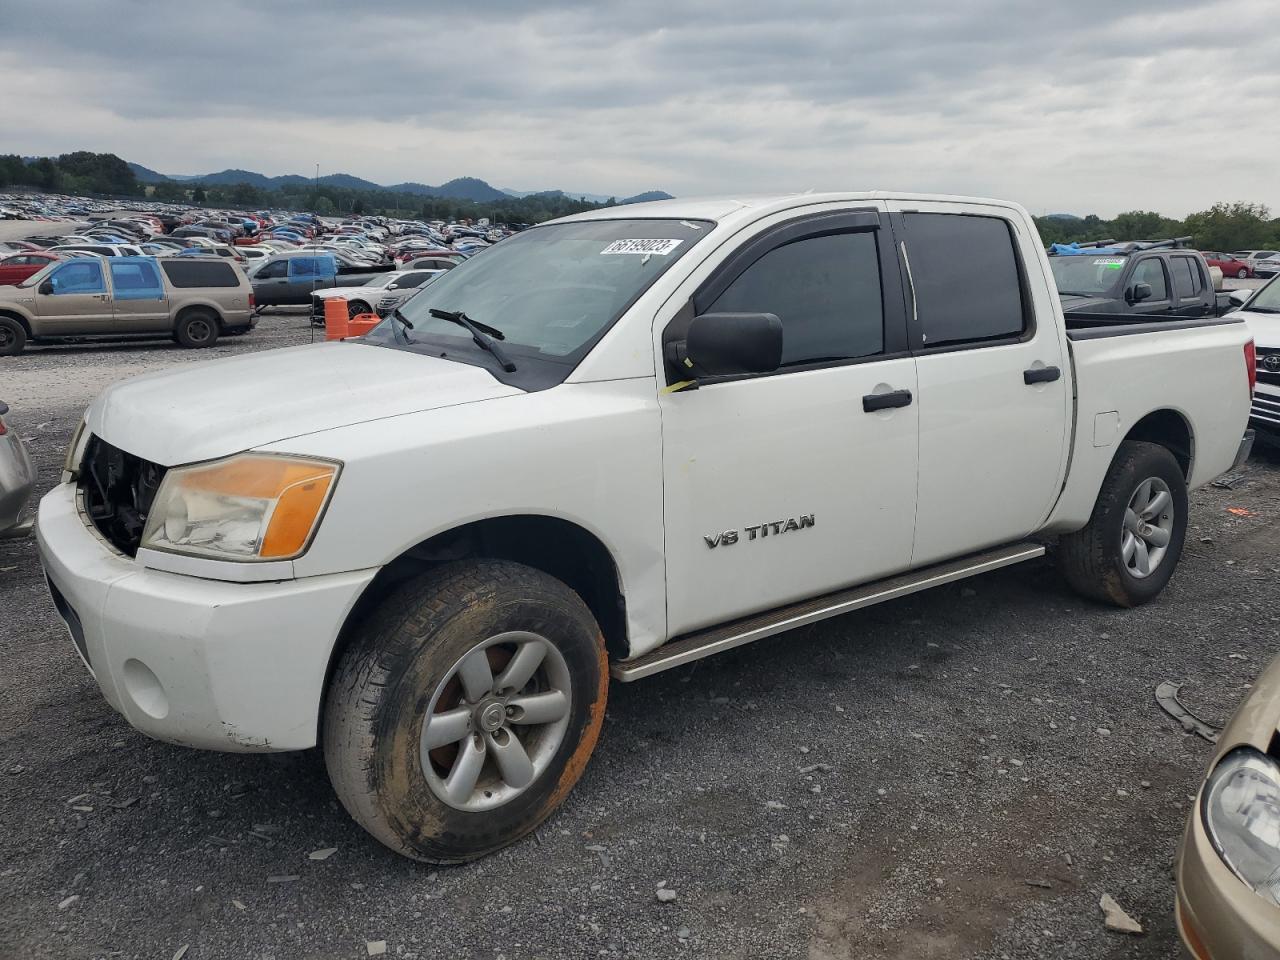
[[317, 513, 628, 737]]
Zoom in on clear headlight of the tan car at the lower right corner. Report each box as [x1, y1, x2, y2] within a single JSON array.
[[1201, 748, 1280, 905]]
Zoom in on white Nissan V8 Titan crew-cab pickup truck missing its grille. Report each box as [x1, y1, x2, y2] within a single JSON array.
[[37, 193, 1253, 863]]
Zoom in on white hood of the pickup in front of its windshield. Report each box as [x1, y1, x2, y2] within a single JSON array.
[[87, 343, 521, 466]]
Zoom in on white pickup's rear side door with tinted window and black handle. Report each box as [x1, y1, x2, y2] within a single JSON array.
[[890, 201, 1071, 567]]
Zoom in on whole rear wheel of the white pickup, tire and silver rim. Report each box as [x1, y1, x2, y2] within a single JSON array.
[[1059, 442, 1187, 607]]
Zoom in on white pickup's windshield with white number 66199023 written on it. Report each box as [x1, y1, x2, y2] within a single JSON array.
[[365, 219, 714, 383]]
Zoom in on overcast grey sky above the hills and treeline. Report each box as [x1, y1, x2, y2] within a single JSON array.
[[0, 0, 1280, 216]]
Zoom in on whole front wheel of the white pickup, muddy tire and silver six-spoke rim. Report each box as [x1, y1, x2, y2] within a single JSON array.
[[323, 561, 608, 864]]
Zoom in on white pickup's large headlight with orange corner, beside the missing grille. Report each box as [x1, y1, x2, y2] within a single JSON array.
[[142, 453, 340, 561]]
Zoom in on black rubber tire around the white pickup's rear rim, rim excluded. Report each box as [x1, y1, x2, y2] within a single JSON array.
[[1057, 440, 1187, 607]]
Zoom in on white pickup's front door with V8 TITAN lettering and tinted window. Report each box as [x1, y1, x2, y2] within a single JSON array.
[[659, 206, 919, 635]]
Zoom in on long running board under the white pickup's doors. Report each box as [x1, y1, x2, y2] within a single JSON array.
[[609, 543, 1044, 684]]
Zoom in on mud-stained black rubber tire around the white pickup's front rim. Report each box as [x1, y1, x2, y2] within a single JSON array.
[[321, 561, 608, 864]]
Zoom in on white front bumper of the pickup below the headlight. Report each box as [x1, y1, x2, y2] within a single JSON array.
[[36, 484, 376, 751]]
